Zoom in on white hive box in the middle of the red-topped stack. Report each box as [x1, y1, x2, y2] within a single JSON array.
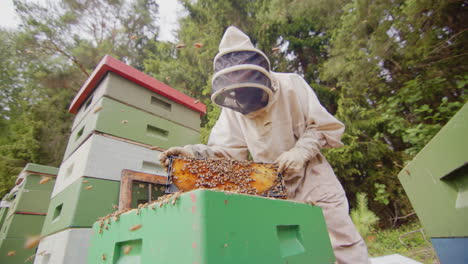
[[51, 134, 167, 197]]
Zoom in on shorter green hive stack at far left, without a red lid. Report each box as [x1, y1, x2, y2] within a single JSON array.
[[0, 163, 58, 264]]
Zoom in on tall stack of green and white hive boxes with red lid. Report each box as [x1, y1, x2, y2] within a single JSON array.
[[35, 56, 205, 264]]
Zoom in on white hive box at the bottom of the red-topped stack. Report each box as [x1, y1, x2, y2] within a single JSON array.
[[34, 228, 93, 264]]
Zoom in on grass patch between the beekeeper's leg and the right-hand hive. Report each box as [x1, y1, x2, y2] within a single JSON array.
[[365, 223, 439, 264]]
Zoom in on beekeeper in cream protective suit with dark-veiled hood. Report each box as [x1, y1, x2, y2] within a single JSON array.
[[160, 26, 369, 264]]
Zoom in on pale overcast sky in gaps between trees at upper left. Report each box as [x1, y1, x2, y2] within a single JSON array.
[[0, 0, 183, 42]]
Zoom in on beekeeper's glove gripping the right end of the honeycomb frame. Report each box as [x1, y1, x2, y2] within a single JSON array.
[[275, 147, 314, 175]]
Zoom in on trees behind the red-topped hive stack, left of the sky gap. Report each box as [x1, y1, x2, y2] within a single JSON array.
[[0, 0, 162, 196]]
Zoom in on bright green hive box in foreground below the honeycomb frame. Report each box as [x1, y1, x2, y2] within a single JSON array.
[[88, 190, 335, 264]]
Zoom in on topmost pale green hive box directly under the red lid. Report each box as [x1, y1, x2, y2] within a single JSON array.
[[72, 72, 200, 131]]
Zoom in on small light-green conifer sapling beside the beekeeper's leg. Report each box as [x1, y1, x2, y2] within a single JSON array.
[[350, 193, 379, 237]]
